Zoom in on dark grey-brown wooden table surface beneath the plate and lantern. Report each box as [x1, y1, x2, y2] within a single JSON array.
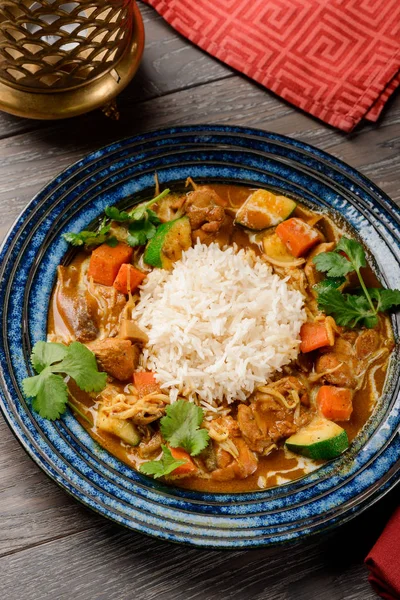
[[0, 5, 400, 600]]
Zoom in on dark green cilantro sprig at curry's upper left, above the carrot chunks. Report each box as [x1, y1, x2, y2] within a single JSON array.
[[63, 189, 170, 247]]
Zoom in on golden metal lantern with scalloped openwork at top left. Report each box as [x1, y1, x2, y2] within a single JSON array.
[[0, 0, 144, 119]]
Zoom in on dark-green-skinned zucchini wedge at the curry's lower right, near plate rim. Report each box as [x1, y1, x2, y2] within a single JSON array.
[[286, 417, 349, 460]]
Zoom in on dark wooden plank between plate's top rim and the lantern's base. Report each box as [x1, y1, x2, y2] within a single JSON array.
[[0, 76, 400, 240]]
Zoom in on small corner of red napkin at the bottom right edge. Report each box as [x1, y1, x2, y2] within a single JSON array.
[[365, 508, 400, 600]]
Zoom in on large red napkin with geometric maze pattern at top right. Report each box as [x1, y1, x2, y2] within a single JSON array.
[[145, 0, 400, 131]]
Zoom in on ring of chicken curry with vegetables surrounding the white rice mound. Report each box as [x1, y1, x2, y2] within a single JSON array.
[[35, 181, 394, 492]]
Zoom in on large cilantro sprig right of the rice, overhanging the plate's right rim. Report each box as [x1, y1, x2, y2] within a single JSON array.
[[313, 237, 400, 329]]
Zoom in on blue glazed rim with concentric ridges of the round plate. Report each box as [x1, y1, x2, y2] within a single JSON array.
[[0, 126, 400, 548]]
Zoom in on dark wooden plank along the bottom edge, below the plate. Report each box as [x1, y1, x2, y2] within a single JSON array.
[[0, 494, 399, 600]]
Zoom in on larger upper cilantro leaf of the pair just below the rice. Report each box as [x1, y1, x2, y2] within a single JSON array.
[[160, 400, 209, 456]]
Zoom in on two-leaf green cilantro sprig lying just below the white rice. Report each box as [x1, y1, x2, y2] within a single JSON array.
[[140, 400, 209, 478]]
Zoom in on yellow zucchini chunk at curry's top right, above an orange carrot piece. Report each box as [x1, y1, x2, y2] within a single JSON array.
[[235, 190, 296, 231]]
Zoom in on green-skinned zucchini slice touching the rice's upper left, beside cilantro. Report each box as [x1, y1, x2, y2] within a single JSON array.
[[143, 217, 192, 271]]
